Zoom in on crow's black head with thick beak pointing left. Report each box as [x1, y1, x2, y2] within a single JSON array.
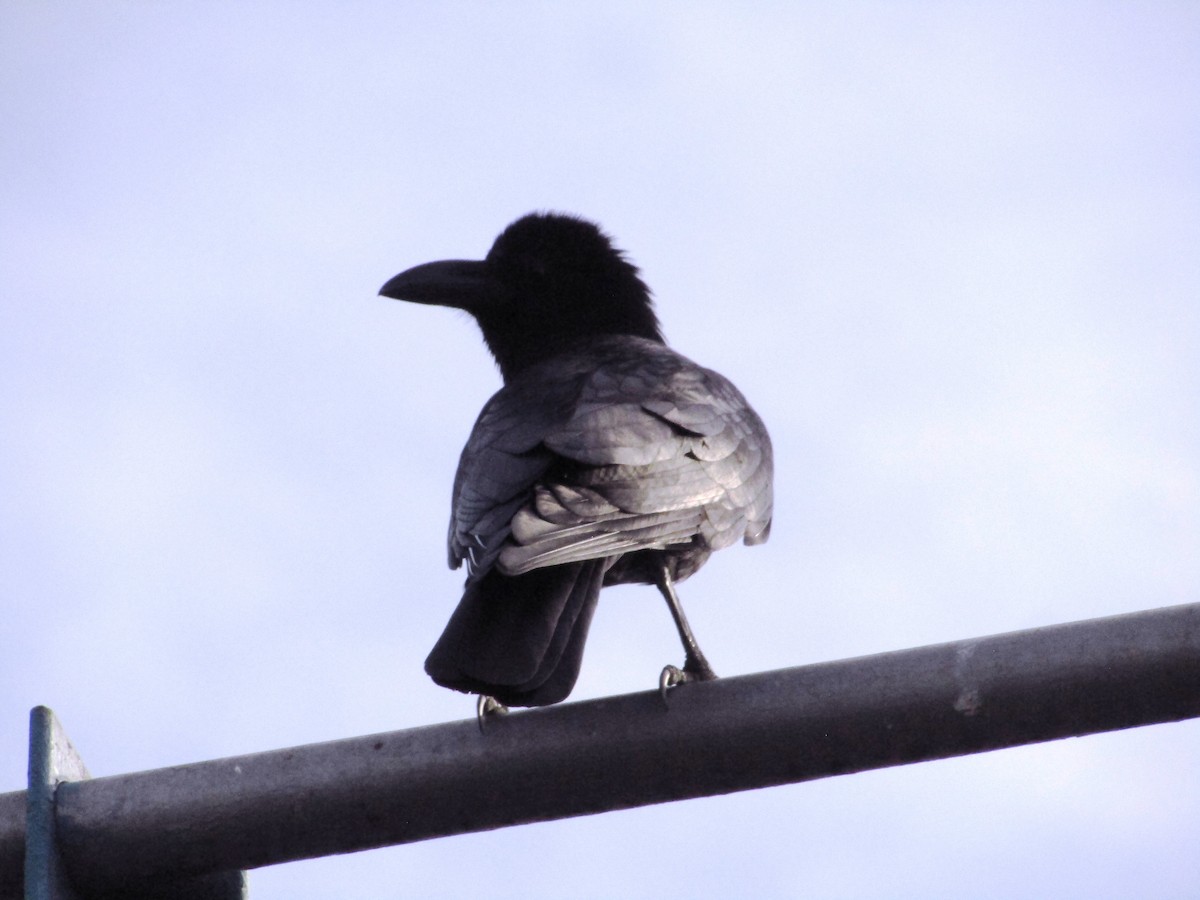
[[379, 212, 662, 379]]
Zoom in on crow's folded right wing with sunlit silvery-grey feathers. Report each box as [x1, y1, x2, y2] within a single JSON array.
[[494, 340, 772, 575]]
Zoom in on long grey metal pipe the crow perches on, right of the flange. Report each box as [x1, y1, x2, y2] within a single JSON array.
[[0, 604, 1200, 884]]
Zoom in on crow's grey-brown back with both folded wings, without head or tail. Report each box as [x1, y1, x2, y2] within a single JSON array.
[[450, 337, 772, 578]]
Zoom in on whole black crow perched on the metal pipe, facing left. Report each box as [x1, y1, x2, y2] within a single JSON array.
[[379, 214, 772, 710]]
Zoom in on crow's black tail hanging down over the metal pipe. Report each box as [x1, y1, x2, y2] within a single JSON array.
[[425, 559, 612, 707]]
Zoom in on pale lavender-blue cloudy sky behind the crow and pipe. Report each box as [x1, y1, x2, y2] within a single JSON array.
[[0, 0, 1200, 900]]
